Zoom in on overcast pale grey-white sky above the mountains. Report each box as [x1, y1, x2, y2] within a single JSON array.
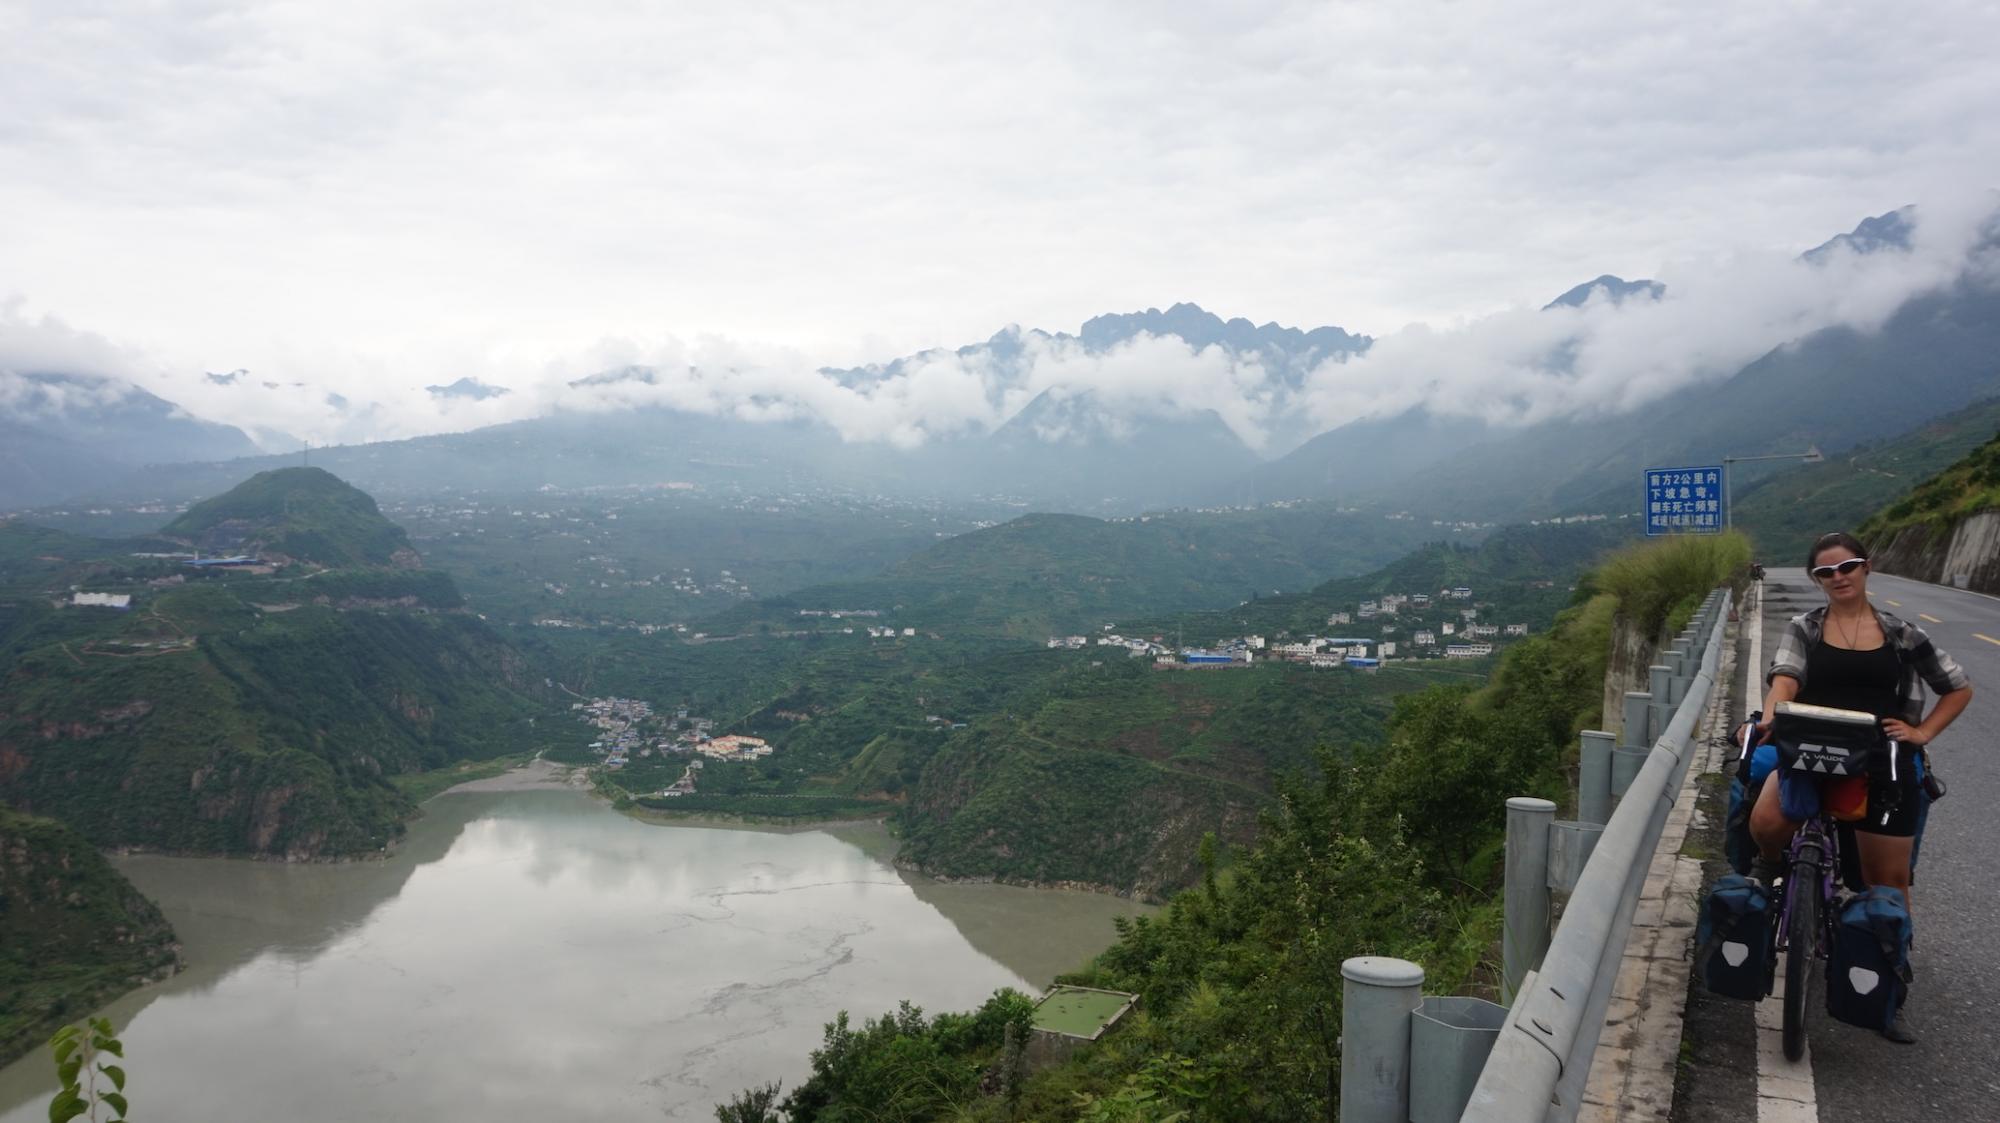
[[0, 0, 2000, 445]]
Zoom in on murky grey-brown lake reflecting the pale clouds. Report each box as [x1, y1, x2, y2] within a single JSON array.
[[0, 791, 1140, 1123]]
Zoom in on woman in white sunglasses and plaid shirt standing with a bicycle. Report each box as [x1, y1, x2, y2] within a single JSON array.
[[1750, 532, 1972, 1043]]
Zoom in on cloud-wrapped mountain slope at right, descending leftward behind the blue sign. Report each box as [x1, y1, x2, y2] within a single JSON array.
[[1240, 208, 2000, 520]]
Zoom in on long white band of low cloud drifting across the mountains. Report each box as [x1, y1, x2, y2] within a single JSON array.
[[15, 192, 2000, 456]]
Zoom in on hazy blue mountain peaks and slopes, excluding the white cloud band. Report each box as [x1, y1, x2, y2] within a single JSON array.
[[0, 208, 2000, 520]]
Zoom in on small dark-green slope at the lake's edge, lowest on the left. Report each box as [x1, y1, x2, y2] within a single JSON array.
[[0, 807, 180, 1065]]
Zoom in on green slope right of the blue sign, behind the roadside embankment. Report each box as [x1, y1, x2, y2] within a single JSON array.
[[1734, 400, 2000, 565]]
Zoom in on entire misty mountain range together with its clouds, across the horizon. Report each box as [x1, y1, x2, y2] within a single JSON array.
[[12, 200, 2000, 518]]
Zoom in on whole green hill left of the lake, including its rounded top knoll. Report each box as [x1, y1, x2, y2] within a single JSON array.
[[0, 468, 550, 857]]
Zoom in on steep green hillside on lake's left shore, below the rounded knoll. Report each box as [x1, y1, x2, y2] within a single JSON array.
[[0, 581, 542, 857]]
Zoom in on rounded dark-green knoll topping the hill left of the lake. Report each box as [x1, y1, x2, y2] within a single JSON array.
[[160, 468, 418, 565]]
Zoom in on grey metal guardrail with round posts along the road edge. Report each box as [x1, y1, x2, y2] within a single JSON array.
[[1340, 589, 1730, 1123]]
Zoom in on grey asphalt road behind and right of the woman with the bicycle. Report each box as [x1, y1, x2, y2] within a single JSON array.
[[1764, 569, 2000, 1123]]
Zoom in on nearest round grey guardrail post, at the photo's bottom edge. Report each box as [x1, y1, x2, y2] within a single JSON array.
[[1340, 955, 1424, 1123]]
